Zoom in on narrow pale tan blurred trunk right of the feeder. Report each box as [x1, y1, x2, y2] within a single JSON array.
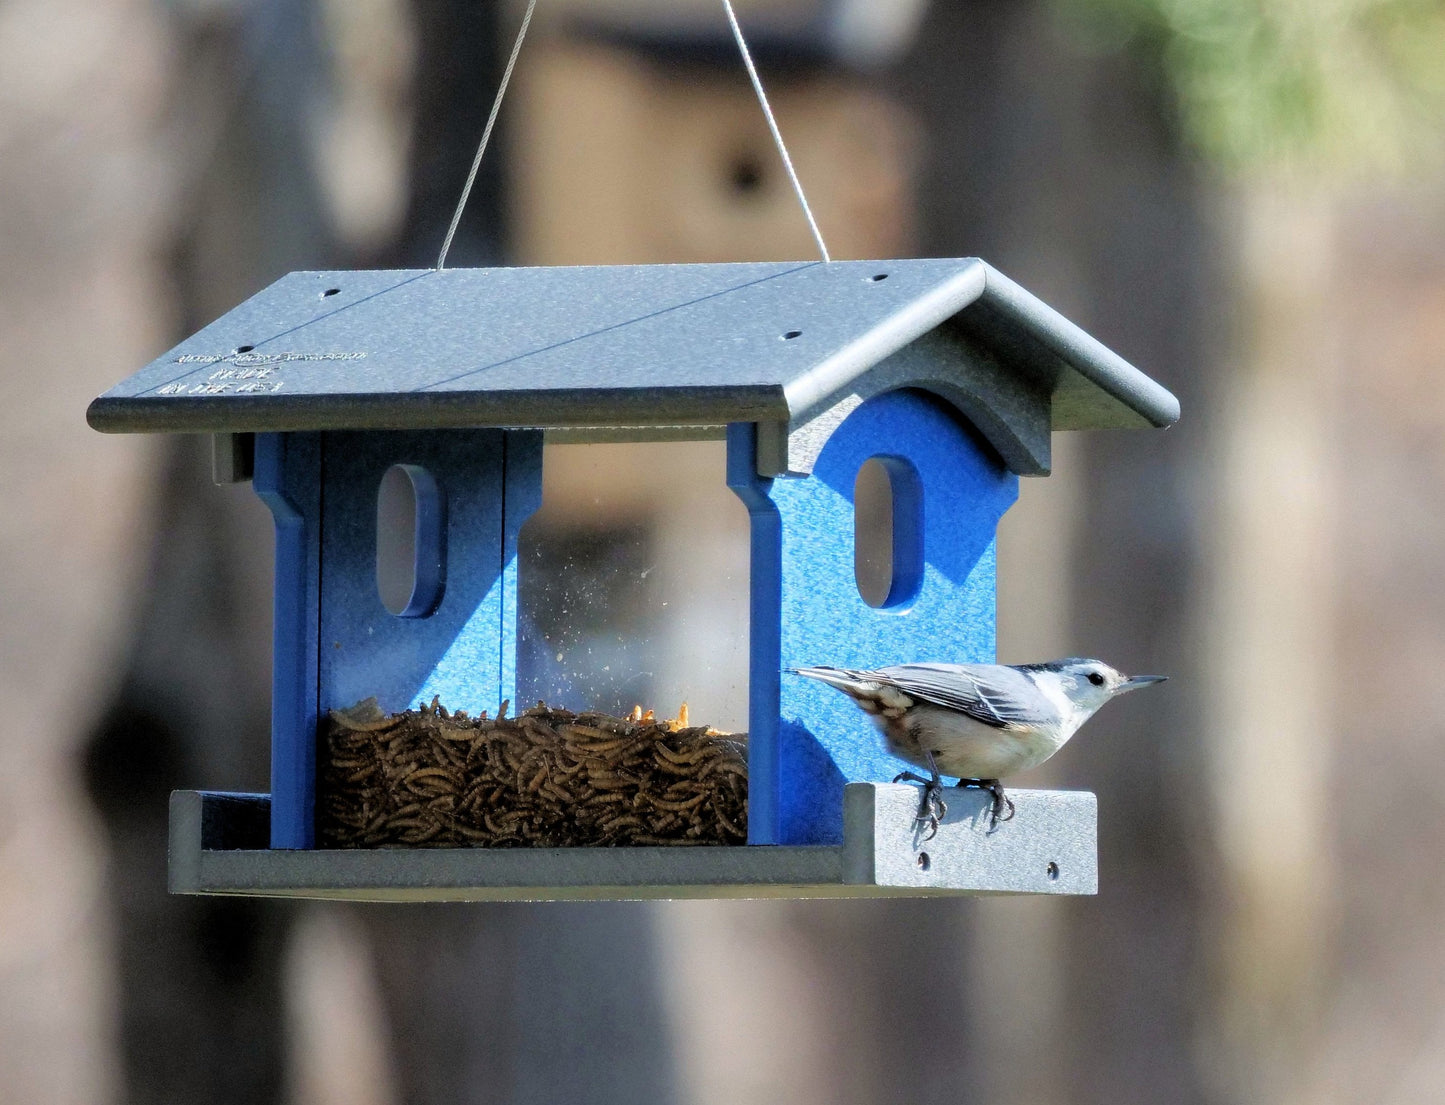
[[1198, 181, 1335, 1102]]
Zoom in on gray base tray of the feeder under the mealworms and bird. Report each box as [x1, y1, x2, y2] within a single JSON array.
[[171, 783, 1098, 901]]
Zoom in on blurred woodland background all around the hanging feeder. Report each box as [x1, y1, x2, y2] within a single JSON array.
[[0, 0, 1445, 1105]]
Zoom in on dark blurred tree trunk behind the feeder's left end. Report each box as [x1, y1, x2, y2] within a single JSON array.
[[77, 0, 335, 1105]]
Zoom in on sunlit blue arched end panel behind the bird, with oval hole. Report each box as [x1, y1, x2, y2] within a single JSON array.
[[728, 391, 1019, 844]]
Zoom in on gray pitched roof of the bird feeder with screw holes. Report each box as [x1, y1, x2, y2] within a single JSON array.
[[87, 259, 1179, 450]]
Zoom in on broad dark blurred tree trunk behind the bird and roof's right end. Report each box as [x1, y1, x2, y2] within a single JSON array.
[[902, 0, 1220, 1102]]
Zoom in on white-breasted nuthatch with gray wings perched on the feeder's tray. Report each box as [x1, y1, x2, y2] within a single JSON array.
[[788, 656, 1168, 839]]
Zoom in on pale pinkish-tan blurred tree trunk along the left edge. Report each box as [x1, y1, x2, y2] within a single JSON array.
[[0, 0, 171, 1105]]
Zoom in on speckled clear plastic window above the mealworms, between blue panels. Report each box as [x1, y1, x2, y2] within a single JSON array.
[[517, 441, 749, 732]]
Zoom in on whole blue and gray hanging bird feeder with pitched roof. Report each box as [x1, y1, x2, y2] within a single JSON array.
[[88, 259, 1178, 900]]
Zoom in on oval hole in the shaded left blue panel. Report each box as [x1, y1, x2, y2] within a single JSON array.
[[376, 464, 447, 618]]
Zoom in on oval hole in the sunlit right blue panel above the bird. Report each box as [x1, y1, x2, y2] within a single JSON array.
[[853, 456, 923, 610]]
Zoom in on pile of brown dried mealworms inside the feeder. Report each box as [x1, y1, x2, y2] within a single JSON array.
[[316, 699, 747, 848]]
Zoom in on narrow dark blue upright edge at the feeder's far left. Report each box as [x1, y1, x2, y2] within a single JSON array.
[[251, 433, 321, 848]]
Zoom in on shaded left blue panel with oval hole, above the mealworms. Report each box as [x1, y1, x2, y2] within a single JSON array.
[[318, 430, 506, 712]]
